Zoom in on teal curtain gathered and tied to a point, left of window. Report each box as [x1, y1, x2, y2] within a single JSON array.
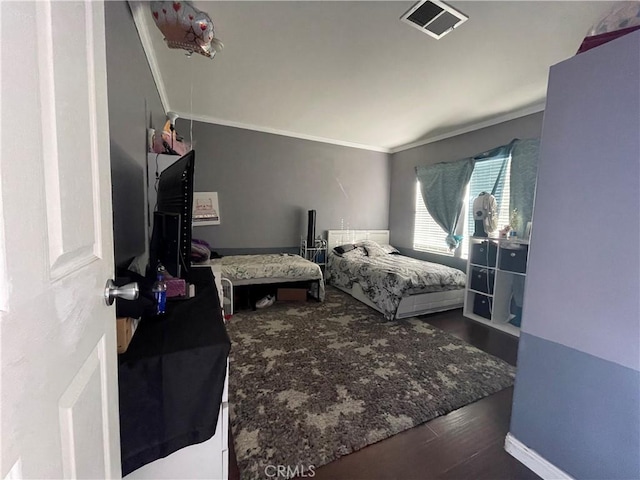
[[416, 158, 475, 250]]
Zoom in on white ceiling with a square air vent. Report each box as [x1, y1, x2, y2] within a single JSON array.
[[131, 1, 612, 151]]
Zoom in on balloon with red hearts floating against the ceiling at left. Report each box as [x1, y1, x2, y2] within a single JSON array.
[[151, 1, 223, 58]]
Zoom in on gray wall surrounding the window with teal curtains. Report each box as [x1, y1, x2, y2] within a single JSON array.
[[389, 113, 542, 270]]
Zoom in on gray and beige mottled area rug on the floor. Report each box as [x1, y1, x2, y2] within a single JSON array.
[[227, 287, 515, 479]]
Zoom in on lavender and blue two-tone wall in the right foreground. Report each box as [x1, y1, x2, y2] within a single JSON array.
[[511, 32, 640, 479]]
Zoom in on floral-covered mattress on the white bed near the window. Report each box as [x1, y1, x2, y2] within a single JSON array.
[[327, 252, 466, 320]]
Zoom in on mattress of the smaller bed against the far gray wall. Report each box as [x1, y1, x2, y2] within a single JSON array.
[[211, 253, 324, 301]]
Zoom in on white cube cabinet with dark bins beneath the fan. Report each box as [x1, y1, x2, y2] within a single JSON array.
[[463, 237, 529, 336]]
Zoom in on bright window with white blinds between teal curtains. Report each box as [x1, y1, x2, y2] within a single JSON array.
[[413, 157, 511, 258]]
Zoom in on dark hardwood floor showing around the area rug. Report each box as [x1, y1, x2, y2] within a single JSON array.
[[229, 310, 539, 480]]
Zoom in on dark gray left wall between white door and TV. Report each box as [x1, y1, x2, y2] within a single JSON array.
[[105, 2, 165, 263]]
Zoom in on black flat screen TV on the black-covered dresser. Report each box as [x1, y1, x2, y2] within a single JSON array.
[[149, 150, 196, 278]]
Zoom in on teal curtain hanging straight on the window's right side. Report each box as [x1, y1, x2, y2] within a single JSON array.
[[509, 138, 540, 236]]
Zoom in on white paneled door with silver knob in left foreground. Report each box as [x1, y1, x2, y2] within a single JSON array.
[[0, 1, 120, 478]]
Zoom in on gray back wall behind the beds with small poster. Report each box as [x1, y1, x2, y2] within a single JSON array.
[[176, 119, 389, 254]]
